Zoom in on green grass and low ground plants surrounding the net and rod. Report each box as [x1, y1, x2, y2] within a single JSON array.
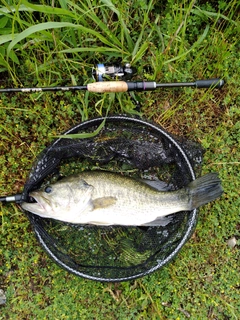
[[0, 0, 240, 320]]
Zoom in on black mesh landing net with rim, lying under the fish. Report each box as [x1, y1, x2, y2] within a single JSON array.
[[23, 116, 203, 281]]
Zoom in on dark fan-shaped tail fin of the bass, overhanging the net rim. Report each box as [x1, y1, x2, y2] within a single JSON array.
[[188, 173, 223, 210]]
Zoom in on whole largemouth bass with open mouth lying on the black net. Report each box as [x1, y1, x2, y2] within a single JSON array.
[[21, 170, 223, 226]]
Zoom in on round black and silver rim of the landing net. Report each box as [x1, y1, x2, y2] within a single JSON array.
[[27, 115, 198, 282]]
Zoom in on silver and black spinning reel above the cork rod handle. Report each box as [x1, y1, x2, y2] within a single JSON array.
[[92, 63, 137, 82]]
